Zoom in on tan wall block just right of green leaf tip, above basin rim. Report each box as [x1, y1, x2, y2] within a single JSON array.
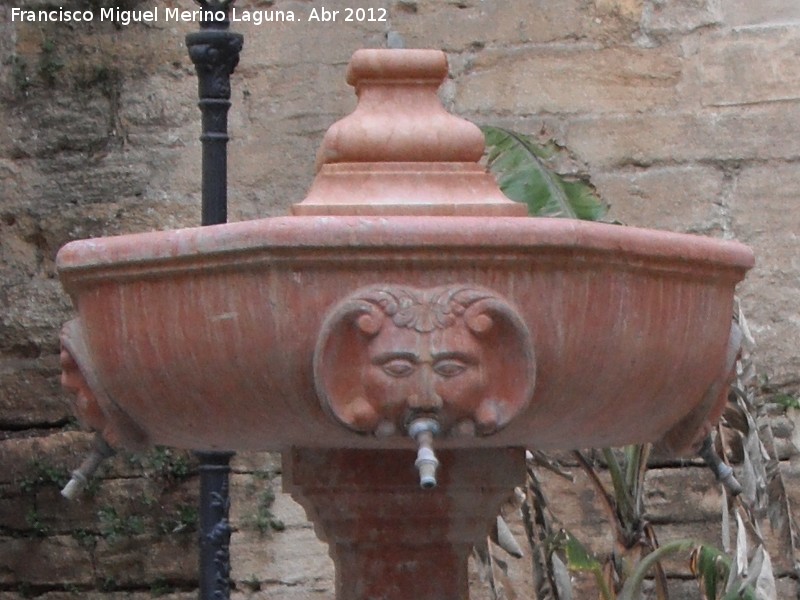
[[592, 165, 726, 234]]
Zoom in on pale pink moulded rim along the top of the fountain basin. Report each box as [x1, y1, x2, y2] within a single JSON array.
[[56, 216, 755, 289]]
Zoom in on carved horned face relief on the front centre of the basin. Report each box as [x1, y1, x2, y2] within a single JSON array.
[[314, 285, 534, 435]]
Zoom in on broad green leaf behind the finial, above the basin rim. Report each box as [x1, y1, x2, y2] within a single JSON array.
[[481, 126, 608, 221]]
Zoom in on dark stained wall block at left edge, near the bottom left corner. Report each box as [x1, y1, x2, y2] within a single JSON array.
[[0, 536, 94, 586]]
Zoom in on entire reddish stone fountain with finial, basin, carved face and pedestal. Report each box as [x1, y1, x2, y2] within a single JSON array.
[[58, 50, 753, 600]]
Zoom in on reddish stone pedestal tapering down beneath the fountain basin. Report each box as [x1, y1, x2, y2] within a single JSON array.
[[283, 448, 525, 600]]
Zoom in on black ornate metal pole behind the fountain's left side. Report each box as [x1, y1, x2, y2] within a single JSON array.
[[186, 0, 244, 600]]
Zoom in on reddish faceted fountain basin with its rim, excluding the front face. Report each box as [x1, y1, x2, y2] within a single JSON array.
[[57, 216, 753, 450]]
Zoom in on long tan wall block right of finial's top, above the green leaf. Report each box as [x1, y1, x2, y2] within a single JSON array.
[[455, 46, 681, 114]]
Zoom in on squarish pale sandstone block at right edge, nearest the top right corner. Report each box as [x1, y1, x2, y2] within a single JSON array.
[[683, 23, 800, 106]]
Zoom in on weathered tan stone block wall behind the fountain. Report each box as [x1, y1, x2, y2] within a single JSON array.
[[0, 0, 800, 600]]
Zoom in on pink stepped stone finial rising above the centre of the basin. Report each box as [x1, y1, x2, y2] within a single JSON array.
[[292, 49, 527, 216]]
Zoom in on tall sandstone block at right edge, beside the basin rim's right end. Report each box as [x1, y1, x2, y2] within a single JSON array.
[[731, 163, 800, 381]]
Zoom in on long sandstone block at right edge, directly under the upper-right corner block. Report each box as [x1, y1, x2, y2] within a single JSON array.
[[564, 102, 800, 170]]
